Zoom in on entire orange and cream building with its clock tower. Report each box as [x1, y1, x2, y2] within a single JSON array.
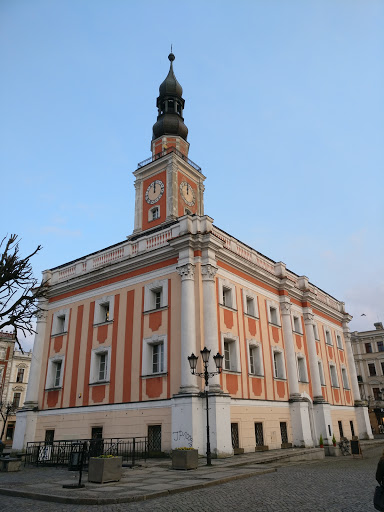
[[13, 54, 371, 457]]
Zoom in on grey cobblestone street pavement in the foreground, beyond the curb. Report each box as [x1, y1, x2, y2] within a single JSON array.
[[0, 446, 382, 512]]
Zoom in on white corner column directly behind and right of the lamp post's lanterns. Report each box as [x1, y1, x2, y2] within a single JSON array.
[[201, 264, 221, 392]]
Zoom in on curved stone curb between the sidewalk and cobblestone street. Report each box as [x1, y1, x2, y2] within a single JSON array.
[[0, 468, 277, 505]]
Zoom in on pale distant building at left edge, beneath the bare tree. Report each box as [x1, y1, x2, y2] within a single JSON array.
[[0, 332, 32, 445]]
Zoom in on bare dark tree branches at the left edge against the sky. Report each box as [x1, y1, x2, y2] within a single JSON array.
[[0, 235, 48, 350]]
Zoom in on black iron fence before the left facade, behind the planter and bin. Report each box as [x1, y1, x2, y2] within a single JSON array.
[[25, 437, 148, 466]]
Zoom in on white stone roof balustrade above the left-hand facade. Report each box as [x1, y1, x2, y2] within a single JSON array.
[[51, 224, 180, 284]]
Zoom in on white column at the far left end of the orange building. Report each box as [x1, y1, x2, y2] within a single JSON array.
[[23, 299, 48, 409]]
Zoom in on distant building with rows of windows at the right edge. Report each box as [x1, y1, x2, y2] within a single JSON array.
[[351, 322, 384, 433]]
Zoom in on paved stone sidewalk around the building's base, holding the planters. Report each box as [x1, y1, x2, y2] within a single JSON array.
[[0, 440, 384, 505]]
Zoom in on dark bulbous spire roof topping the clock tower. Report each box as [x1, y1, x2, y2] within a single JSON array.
[[152, 53, 188, 140]]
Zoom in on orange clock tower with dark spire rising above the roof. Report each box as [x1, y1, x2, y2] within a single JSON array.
[[133, 53, 205, 233]]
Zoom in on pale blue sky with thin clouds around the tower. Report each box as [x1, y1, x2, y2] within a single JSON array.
[[0, 0, 384, 348]]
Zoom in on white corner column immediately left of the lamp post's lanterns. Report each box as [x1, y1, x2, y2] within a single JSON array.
[[177, 263, 199, 393]]
